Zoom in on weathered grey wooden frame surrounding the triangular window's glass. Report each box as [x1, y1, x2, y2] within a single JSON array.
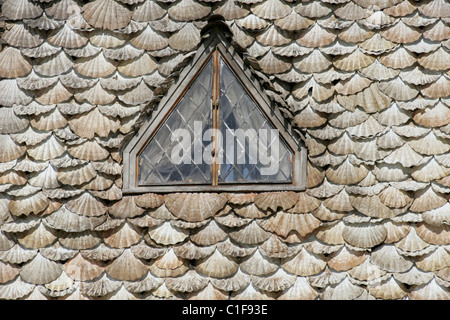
[[122, 31, 307, 194]]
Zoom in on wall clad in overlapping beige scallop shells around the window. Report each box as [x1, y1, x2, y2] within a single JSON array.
[[0, 0, 450, 299]]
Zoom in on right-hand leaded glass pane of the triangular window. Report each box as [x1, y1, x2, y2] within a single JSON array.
[[219, 59, 292, 183]]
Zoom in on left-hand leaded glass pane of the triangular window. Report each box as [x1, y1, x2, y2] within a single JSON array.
[[138, 59, 213, 185]]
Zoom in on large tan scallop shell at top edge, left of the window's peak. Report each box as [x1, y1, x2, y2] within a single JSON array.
[[83, 0, 131, 30]]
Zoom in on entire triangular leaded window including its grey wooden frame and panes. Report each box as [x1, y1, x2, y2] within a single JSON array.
[[123, 29, 306, 193]]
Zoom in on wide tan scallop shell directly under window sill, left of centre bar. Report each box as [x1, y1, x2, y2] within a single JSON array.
[[165, 193, 227, 222]]
